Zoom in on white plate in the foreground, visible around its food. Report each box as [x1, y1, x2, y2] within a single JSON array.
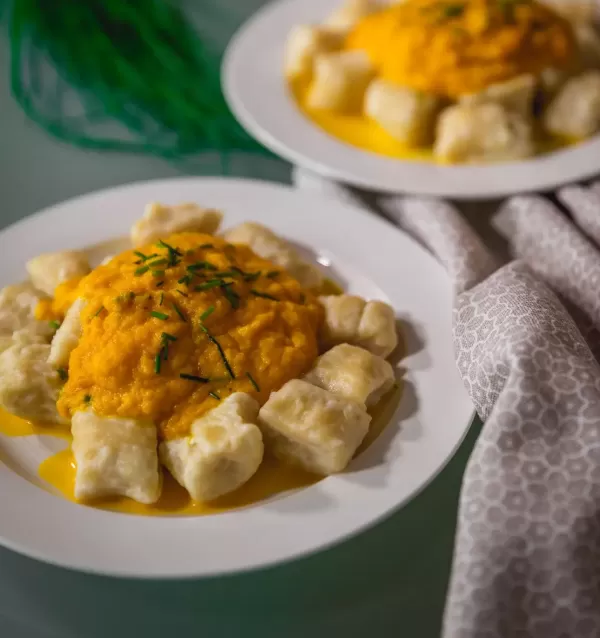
[[0, 178, 472, 578]]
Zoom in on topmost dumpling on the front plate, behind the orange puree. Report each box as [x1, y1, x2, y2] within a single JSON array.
[[131, 203, 223, 246]]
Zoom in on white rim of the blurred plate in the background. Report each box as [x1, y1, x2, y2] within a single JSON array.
[[222, 0, 600, 199]]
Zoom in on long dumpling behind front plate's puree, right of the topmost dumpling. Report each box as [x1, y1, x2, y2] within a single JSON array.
[[223, 222, 323, 288]]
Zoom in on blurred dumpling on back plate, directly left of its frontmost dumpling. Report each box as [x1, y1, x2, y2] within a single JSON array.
[[364, 80, 438, 146]]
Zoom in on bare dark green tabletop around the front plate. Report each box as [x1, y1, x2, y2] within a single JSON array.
[[0, 0, 480, 638]]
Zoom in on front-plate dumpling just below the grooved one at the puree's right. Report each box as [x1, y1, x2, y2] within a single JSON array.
[[304, 343, 394, 405]]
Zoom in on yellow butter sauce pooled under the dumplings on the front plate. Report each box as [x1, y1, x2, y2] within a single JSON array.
[[0, 387, 402, 516]]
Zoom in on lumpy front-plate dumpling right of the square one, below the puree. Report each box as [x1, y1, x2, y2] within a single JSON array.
[[160, 392, 264, 501]]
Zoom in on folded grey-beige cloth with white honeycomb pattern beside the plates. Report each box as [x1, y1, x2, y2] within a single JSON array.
[[295, 170, 600, 638]]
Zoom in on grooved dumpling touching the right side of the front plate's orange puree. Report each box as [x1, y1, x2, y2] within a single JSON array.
[[319, 295, 398, 358]]
